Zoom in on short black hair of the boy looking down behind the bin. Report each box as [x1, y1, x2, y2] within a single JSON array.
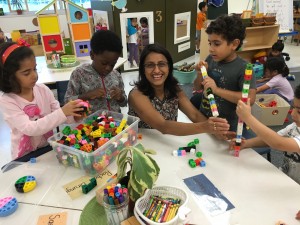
[[91, 30, 123, 55]]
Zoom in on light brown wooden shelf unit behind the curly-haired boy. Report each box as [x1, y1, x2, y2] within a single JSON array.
[[200, 24, 279, 61]]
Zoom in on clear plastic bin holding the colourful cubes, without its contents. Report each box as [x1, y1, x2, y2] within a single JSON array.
[[48, 110, 139, 176]]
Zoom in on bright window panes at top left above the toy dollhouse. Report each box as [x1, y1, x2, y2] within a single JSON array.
[[0, 0, 91, 14]]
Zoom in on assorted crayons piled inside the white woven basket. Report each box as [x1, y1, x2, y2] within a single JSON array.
[[143, 195, 181, 223]]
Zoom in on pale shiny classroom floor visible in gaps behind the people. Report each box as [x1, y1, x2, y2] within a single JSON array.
[[0, 38, 300, 168]]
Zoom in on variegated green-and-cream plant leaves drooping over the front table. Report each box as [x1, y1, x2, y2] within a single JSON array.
[[117, 144, 160, 202]]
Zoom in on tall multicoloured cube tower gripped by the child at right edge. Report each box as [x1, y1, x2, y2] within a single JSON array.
[[234, 63, 253, 157]]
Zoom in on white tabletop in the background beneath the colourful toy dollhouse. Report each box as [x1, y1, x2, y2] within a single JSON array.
[[36, 56, 127, 84]]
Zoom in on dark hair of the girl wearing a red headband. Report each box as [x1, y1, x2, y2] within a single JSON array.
[[0, 42, 34, 94]]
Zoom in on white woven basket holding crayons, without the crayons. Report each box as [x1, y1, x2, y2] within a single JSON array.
[[134, 186, 188, 225]]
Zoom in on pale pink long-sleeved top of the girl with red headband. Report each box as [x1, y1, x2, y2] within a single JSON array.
[[0, 84, 73, 159]]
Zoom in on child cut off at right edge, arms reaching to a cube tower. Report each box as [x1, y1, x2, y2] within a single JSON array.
[[230, 85, 300, 184]]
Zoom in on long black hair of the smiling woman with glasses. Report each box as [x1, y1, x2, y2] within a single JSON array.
[[134, 43, 180, 99]]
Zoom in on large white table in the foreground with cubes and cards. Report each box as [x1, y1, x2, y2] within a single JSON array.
[[0, 130, 300, 225]]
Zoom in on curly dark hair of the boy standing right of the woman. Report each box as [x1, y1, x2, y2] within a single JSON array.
[[206, 14, 246, 51]]
